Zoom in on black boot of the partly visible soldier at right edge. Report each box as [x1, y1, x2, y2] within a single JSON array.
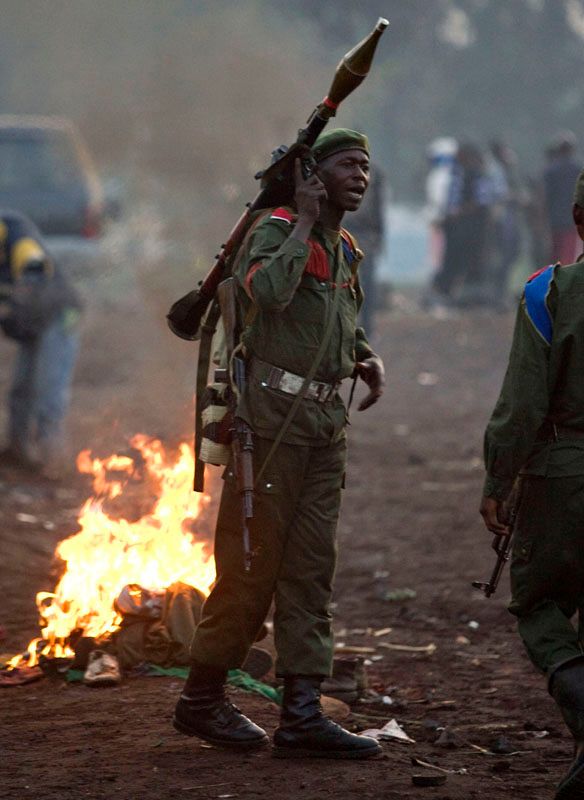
[[549, 658, 584, 800]]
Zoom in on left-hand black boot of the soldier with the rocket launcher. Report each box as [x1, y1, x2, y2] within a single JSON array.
[[172, 663, 268, 750]]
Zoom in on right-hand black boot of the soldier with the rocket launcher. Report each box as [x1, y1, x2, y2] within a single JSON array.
[[274, 675, 381, 758]]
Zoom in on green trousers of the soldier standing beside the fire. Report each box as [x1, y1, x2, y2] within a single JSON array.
[[191, 436, 346, 676]]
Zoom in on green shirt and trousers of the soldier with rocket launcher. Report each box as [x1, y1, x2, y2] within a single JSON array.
[[191, 208, 372, 676]]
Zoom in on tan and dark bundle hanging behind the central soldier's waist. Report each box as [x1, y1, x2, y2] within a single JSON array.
[[199, 383, 233, 466]]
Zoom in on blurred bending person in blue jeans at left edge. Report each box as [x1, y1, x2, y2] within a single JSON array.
[[0, 211, 81, 479]]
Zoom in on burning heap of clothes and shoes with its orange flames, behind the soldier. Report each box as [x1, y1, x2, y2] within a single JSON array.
[[0, 435, 365, 703]]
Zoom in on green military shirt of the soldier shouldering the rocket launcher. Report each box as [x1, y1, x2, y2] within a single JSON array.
[[234, 208, 372, 446]]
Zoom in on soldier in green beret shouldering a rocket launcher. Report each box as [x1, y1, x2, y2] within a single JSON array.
[[174, 129, 385, 758]]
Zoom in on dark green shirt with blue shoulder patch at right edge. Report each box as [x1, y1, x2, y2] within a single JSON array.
[[484, 261, 584, 500]]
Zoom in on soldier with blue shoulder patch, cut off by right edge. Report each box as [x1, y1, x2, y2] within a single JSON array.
[[480, 172, 584, 800]]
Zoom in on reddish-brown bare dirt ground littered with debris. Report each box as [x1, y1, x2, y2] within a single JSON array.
[[0, 300, 570, 800]]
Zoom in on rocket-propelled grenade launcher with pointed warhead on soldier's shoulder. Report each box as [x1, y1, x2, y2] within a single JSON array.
[[167, 17, 389, 340]]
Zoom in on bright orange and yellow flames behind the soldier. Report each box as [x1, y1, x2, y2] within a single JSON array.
[[12, 434, 215, 666]]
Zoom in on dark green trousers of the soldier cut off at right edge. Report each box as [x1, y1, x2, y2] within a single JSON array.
[[509, 475, 584, 675]]
